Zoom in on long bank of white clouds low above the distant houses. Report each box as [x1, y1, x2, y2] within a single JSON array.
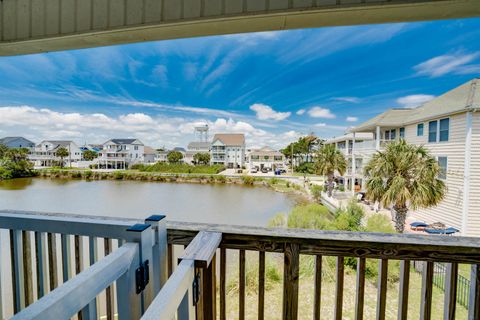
[[0, 106, 300, 149]]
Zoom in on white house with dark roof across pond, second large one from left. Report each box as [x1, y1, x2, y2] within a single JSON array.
[[96, 139, 145, 169]]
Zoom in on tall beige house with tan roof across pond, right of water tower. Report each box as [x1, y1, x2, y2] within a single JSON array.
[[210, 133, 245, 169]]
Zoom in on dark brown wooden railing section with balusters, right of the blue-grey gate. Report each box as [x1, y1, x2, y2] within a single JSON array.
[[167, 222, 480, 320]]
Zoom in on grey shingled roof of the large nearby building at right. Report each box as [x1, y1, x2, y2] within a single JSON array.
[[349, 78, 480, 132]]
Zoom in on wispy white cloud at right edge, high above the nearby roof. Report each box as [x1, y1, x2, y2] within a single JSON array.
[[413, 52, 480, 78]]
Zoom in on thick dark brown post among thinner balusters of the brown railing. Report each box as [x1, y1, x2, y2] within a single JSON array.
[[283, 243, 300, 320]]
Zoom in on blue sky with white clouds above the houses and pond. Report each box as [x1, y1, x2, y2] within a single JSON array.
[[0, 19, 480, 148]]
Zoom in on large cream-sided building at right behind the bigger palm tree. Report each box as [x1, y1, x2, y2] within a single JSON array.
[[351, 79, 480, 236]]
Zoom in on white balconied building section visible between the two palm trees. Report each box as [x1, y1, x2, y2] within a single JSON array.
[[324, 132, 375, 192]]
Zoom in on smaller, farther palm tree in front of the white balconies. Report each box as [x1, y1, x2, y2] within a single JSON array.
[[315, 144, 347, 197]]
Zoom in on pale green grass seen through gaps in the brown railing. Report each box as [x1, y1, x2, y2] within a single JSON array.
[[222, 250, 467, 320]]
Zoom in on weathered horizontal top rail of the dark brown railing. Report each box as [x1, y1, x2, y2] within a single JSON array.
[[167, 221, 480, 264]]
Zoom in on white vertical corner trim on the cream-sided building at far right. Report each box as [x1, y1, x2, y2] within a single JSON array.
[[461, 112, 473, 236]]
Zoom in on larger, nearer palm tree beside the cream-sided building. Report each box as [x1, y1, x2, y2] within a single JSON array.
[[365, 139, 446, 233]]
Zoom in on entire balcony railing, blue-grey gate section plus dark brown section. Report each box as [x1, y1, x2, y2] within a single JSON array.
[[0, 210, 480, 320]]
